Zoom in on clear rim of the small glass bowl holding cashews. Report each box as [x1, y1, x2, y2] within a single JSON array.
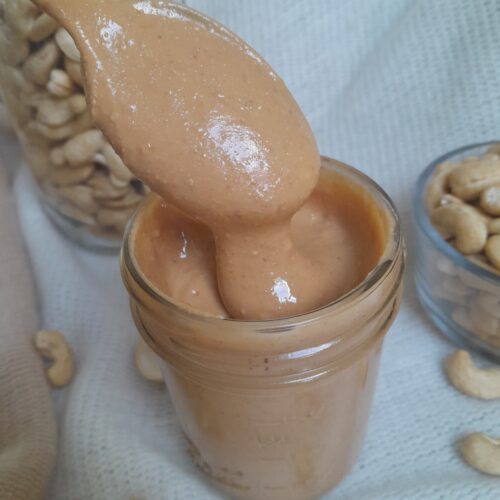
[[412, 140, 500, 286]]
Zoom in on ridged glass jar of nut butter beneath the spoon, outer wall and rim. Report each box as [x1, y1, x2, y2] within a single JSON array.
[[121, 158, 404, 500]]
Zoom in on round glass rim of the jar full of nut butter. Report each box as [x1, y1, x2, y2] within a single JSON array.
[[121, 156, 404, 333]]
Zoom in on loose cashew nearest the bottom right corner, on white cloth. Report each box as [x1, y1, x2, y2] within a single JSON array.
[[460, 432, 500, 476]]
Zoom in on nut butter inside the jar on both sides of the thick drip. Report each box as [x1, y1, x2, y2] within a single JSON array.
[[134, 171, 387, 317]]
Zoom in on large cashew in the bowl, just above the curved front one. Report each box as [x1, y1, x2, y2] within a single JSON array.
[[448, 156, 500, 201]]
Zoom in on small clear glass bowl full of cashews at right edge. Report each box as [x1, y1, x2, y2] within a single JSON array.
[[413, 142, 500, 362]]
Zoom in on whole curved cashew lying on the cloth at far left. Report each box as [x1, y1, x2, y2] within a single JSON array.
[[35, 330, 73, 387]]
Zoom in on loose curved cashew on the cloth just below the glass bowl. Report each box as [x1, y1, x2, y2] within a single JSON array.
[[446, 351, 500, 399]]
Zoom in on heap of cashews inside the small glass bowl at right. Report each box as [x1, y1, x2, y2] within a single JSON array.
[[425, 145, 500, 348]]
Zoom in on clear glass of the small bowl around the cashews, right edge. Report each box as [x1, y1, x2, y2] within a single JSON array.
[[413, 142, 500, 361]]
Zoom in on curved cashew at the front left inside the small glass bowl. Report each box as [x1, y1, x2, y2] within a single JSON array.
[[431, 203, 488, 254]]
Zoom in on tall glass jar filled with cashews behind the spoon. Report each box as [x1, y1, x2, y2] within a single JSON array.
[[0, 0, 145, 251]]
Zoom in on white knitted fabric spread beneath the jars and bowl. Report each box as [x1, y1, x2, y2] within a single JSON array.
[[7, 0, 500, 500]]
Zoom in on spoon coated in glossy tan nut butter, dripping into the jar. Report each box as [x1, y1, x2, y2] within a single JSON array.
[[36, 0, 342, 319]]
